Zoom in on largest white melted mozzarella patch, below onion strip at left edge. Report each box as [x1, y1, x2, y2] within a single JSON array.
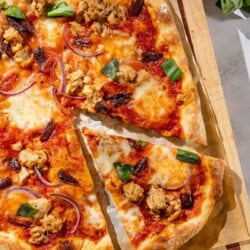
[[4, 86, 57, 130]]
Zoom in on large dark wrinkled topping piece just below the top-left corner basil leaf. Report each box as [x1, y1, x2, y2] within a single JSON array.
[[7, 16, 35, 36]]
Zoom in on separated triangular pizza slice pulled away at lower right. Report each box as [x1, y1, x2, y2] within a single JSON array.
[[83, 128, 224, 250]]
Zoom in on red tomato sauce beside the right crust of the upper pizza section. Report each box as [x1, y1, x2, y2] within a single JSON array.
[[102, 6, 183, 137]]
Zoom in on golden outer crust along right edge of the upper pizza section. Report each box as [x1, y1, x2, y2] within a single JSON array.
[[146, 0, 207, 145]]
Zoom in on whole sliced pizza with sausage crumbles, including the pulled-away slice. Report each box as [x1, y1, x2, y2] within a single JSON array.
[[0, 0, 225, 250]]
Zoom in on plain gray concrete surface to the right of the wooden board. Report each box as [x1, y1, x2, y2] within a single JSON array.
[[203, 0, 250, 197]]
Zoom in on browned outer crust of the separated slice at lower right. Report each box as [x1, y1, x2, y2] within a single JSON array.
[[138, 157, 225, 250]]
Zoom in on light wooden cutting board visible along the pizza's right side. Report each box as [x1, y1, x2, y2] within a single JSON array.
[[170, 0, 250, 250]]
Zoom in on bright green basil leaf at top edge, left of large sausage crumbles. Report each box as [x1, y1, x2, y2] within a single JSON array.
[[46, 2, 74, 17]]
